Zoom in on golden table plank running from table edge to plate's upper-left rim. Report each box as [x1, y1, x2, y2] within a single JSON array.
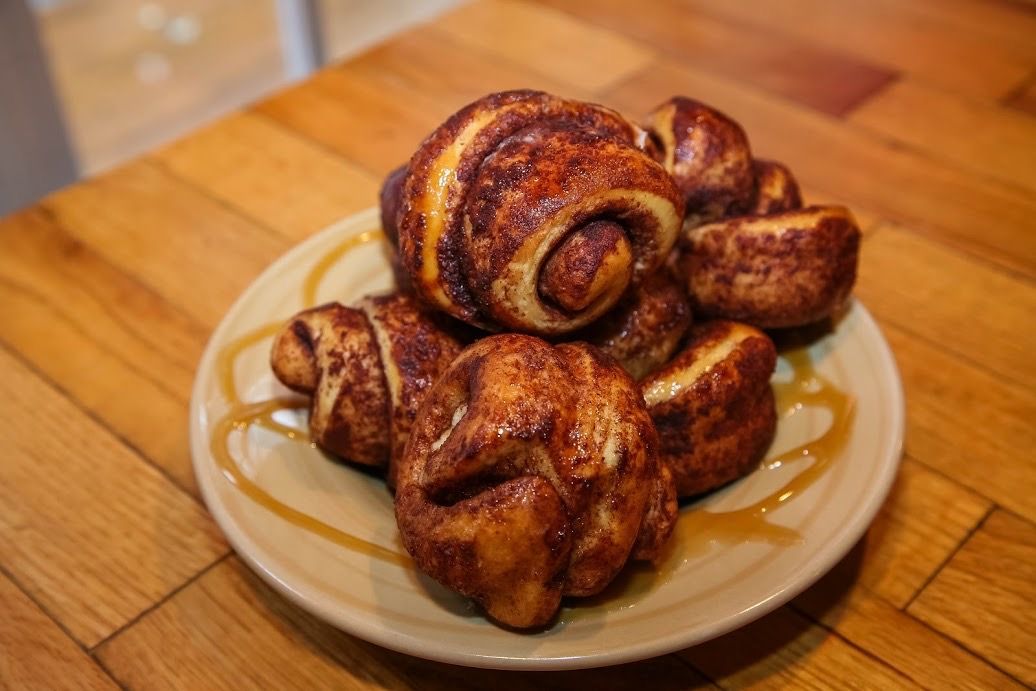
[[42, 162, 289, 327]]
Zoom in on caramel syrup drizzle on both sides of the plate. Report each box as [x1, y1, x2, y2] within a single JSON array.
[[211, 230, 854, 580]]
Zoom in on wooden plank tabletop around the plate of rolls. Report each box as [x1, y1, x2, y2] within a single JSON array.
[[0, 0, 1036, 689]]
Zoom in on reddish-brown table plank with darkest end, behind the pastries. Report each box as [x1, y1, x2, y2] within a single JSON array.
[[546, 0, 894, 115]]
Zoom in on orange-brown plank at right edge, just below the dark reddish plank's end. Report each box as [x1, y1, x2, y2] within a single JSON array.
[[850, 79, 1036, 192]]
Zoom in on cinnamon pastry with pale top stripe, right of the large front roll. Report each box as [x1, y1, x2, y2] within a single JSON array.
[[640, 321, 777, 496]]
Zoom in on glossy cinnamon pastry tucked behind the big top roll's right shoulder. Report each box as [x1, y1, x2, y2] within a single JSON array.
[[646, 96, 755, 228]]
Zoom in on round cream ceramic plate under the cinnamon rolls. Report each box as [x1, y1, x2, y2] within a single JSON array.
[[191, 209, 903, 669]]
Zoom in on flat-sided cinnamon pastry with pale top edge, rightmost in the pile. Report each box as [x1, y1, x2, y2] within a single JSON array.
[[681, 206, 860, 328]]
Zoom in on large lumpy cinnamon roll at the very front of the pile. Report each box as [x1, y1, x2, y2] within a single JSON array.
[[396, 335, 677, 628]]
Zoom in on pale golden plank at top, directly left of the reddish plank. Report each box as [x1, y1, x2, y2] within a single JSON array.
[[435, 0, 653, 92]]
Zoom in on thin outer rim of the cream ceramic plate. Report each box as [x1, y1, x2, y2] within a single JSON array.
[[188, 207, 905, 670]]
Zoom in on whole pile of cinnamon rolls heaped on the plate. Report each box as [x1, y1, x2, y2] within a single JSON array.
[[271, 91, 860, 628]]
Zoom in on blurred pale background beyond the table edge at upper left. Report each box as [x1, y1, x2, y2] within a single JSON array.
[[0, 0, 459, 214]]
